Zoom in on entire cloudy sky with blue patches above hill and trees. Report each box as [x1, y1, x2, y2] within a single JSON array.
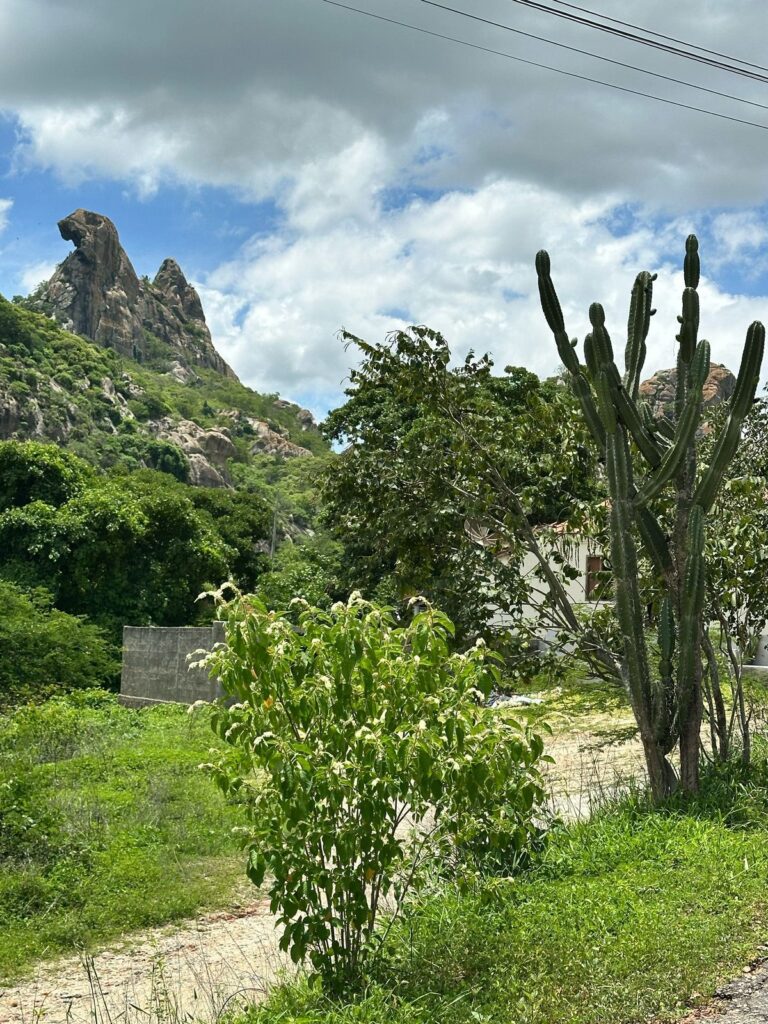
[[0, 0, 768, 415]]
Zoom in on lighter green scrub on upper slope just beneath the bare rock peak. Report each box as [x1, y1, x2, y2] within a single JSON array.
[[0, 297, 328, 460]]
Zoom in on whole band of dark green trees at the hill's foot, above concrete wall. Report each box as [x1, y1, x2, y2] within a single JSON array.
[[0, 441, 269, 639]]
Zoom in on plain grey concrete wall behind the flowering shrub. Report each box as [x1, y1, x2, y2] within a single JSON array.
[[120, 623, 224, 707]]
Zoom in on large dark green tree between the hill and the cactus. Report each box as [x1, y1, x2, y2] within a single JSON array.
[[323, 328, 596, 636]]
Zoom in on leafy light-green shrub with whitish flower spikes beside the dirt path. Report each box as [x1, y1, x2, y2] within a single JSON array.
[[208, 595, 544, 985]]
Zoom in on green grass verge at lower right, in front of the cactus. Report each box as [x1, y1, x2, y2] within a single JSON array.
[[247, 749, 768, 1024]]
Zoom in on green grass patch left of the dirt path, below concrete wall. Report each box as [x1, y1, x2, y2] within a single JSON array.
[[0, 691, 243, 982]]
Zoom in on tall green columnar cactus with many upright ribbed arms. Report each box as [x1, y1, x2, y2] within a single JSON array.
[[536, 234, 765, 799]]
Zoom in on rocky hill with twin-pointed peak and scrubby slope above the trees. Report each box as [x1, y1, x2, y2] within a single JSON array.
[[0, 210, 328, 487]]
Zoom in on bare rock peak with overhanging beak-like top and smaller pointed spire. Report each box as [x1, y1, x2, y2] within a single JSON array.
[[34, 210, 234, 377]]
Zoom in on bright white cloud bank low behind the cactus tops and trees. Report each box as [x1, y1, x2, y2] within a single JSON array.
[[203, 161, 768, 413]]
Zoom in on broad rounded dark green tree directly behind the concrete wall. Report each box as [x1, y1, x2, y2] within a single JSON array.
[[0, 462, 232, 637]]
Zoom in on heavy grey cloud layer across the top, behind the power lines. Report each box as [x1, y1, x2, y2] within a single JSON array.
[[0, 0, 766, 209]]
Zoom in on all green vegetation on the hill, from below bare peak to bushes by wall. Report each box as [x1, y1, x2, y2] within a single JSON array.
[[0, 298, 339, 706]]
